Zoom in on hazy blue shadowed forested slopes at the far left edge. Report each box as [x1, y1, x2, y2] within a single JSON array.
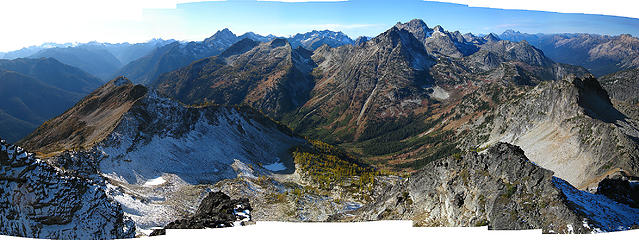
[[0, 58, 101, 142]]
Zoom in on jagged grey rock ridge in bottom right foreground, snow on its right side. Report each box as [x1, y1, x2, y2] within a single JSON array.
[[336, 143, 639, 233]]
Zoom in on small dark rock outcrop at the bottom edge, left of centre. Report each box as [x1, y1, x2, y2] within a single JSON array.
[[151, 192, 253, 236]]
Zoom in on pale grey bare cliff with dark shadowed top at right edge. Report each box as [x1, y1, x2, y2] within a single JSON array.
[[486, 74, 639, 189]]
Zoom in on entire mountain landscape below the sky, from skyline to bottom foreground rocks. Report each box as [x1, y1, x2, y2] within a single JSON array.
[[0, 19, 639, 239]]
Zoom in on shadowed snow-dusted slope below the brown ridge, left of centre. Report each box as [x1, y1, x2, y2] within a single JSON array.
[[91, 93, 305, 233]]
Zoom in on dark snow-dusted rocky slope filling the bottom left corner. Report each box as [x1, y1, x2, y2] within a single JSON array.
[[0, 140, 135, 239]]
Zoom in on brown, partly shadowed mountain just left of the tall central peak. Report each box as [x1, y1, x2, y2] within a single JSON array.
[[153, 39, 314, 116]]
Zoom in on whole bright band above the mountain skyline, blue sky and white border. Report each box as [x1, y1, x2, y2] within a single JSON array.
[[0, 0, 639, 51]]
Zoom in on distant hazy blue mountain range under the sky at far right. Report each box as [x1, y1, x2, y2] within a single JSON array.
[[500, 30, 639, 76]]
